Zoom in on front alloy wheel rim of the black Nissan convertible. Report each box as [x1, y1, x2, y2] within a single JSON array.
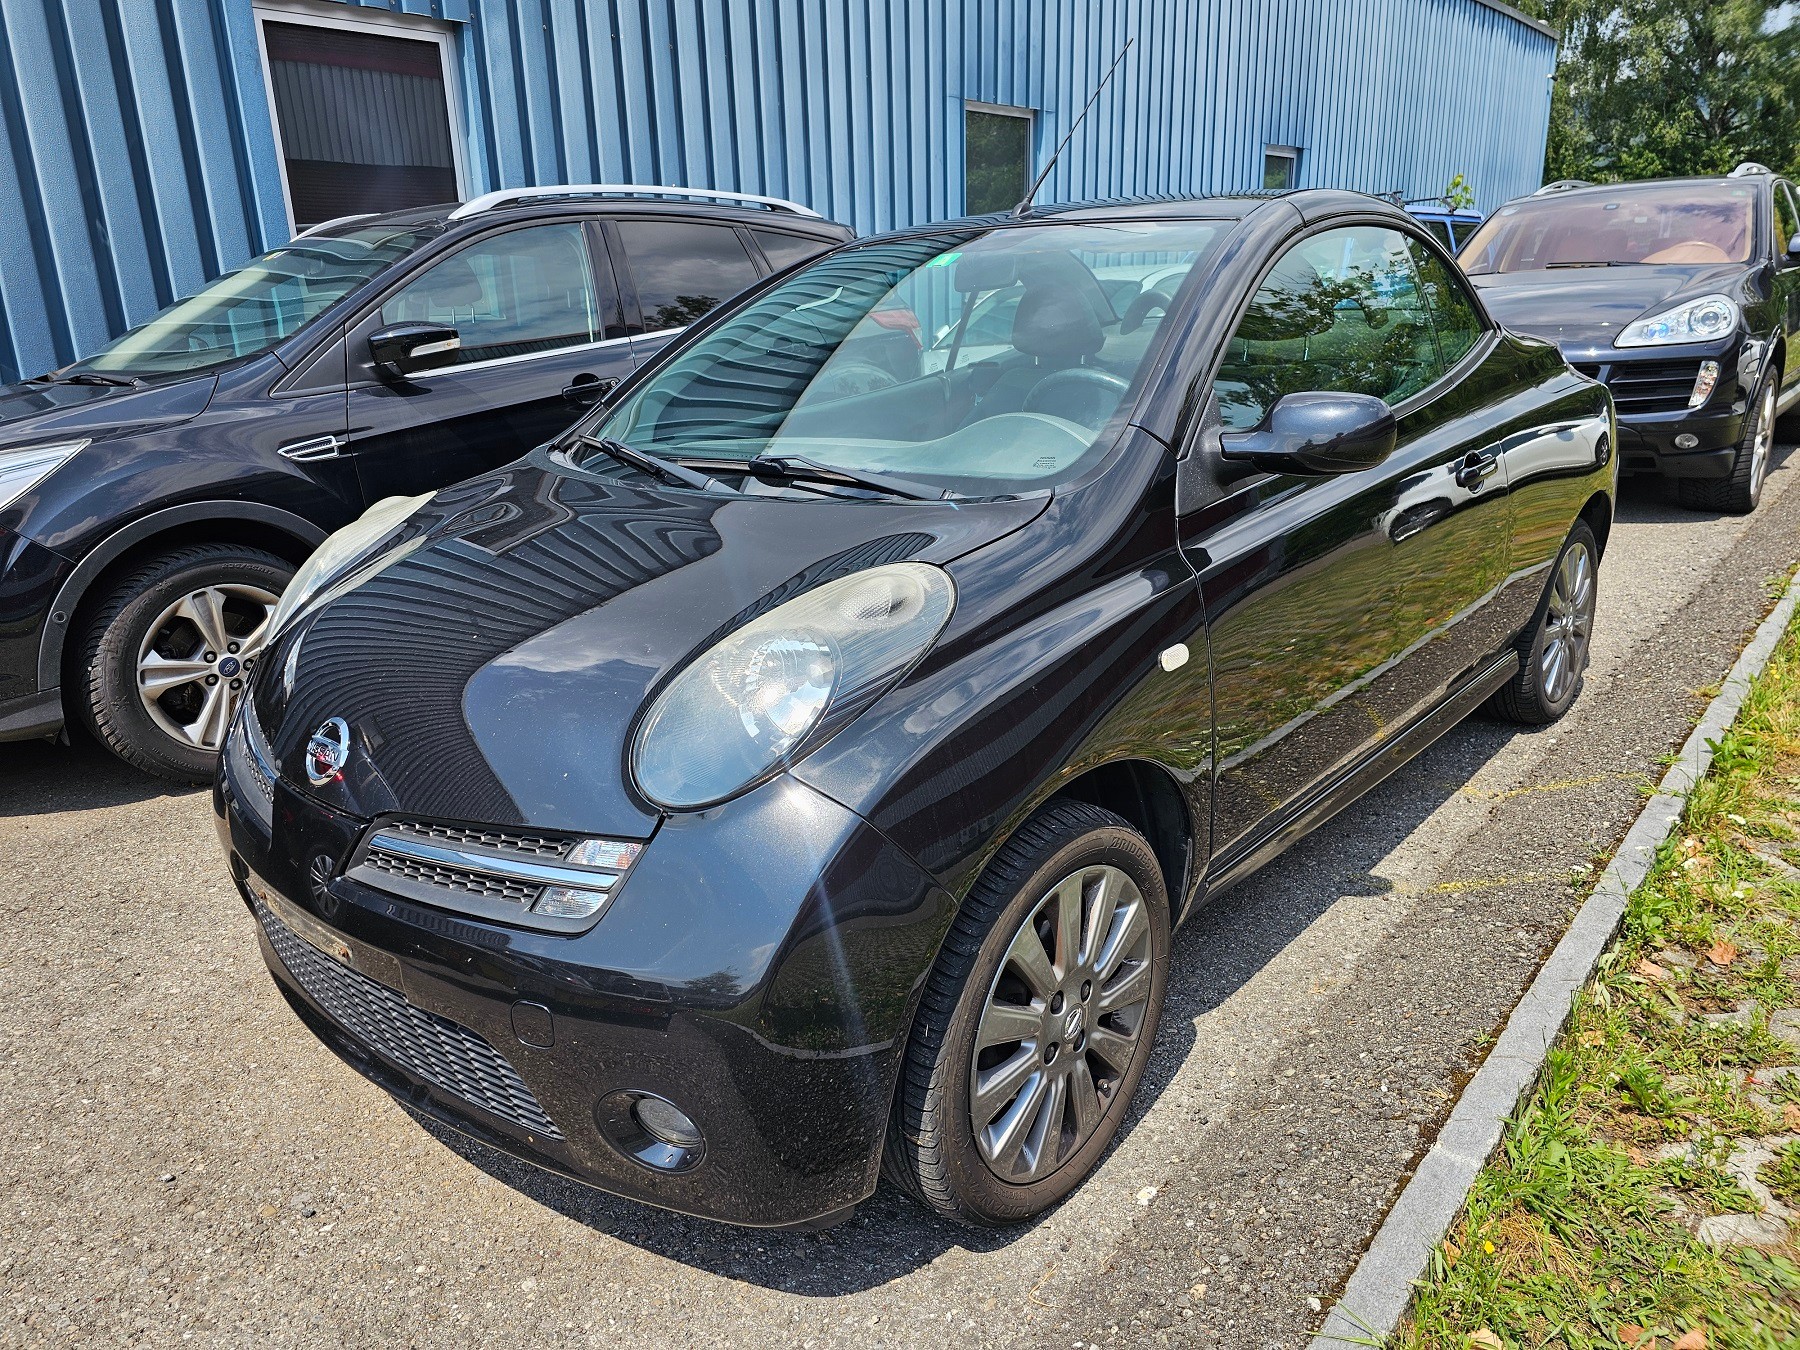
[[968, 866, 1152, 1183]]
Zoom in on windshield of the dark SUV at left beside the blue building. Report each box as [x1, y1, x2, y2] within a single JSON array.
[[72, 227, 434, 374]]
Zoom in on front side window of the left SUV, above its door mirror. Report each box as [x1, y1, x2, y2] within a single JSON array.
[[382, 223, 608, 365]]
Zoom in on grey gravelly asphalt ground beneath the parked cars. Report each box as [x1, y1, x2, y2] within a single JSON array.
[[0, 450, 1800, 1346]]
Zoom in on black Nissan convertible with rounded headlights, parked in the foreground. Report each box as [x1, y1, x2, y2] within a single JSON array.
[[216, 193, 1616, 1226]]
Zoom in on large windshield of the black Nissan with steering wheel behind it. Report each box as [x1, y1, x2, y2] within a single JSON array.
[[583, 221, 1224, 497]]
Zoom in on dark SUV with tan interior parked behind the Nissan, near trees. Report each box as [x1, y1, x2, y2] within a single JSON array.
[[1458, 164, 1800, 515]]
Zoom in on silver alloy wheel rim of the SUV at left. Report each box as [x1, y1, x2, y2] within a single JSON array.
[[137, 583, 275, 751]]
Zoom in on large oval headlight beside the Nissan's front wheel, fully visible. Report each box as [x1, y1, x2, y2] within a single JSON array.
[[632, 563, 956, 810]]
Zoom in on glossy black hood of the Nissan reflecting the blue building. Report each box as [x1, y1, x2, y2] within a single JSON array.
[[254, 452, 1048, 837]]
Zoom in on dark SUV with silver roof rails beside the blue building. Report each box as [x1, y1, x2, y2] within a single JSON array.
[[0, 185, 851, 781]]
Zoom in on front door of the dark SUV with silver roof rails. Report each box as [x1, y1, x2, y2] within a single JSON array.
[[347, 218, 634, 500]]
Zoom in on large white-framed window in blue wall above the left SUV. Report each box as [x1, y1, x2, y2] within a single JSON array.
[[257, 9, 463, 230]]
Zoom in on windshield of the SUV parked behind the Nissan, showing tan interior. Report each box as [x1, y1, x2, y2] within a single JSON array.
[[1456, 182, 1757, 277]]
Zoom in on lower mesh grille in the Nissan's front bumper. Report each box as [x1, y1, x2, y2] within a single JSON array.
[[256, 900, 563, 1139]]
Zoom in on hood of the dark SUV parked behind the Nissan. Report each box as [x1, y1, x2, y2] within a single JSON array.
[[1471, 265, 1744, 355]]
